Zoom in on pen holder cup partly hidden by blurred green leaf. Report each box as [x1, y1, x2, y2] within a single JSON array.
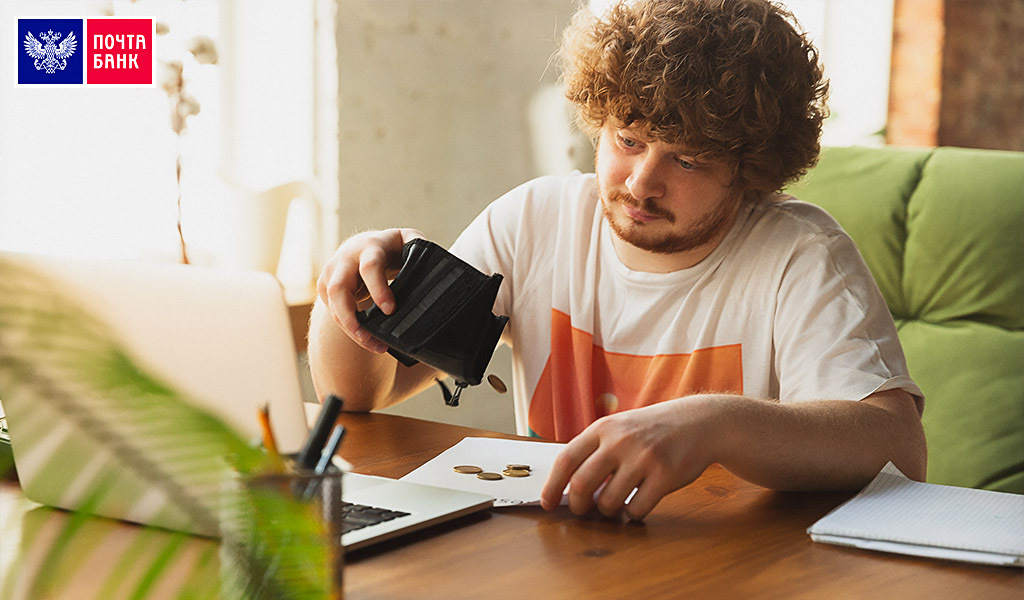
[[224, 468, 344, 599]]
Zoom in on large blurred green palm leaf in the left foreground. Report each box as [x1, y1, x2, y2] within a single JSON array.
[[0, 254, 337, 598]]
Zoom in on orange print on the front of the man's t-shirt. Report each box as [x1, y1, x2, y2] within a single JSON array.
[[529, 309, 743, 441]]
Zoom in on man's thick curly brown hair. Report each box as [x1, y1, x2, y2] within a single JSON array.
[[561, 0, 828, 196]]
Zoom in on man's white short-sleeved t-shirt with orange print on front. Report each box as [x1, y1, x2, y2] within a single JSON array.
[[452, 173, 923, 441]]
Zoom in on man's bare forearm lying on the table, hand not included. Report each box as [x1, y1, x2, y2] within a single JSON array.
[[713, 390, 927, 489]]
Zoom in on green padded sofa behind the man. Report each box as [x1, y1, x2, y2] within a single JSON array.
[[787, 143, 1024, 494]]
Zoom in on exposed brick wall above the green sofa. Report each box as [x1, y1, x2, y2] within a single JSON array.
[[887, 0, 1024, 151]]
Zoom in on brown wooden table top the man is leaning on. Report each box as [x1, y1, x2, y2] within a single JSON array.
[[0, 414, 1024, 600]]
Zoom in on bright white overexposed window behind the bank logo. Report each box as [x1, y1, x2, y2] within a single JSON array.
[[0, 0, 337, 282]]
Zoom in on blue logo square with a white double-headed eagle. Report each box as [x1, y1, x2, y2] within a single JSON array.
[[16, 18, 85, 85]]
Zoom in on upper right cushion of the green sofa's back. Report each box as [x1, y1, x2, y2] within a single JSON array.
[[903, 148, 1024, 329]]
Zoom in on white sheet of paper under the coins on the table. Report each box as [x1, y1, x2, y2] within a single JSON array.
[[401, 437, 565, 506]]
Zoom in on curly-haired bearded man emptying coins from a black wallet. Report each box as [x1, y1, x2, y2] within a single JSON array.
[[309, 0, 926, 519]]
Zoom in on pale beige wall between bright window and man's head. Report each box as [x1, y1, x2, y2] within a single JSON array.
[[337, 0, 589, 431]]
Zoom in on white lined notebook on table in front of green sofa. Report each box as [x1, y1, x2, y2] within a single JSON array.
[[807, 463, 1024, 566]]
